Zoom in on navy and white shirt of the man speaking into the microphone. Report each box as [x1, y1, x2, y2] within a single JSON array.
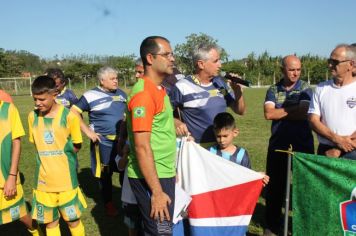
[[169, 76, 235, 144]]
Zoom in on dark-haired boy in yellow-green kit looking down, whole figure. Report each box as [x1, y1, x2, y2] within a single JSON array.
[[28, 76, 86, 236]]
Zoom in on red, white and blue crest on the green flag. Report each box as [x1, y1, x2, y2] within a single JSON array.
[[340, 187, 356, 236]]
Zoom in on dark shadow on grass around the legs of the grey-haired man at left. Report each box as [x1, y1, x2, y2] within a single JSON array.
[[78, 168, 127, 235]]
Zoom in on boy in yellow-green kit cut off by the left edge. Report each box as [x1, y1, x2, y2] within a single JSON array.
[[0, 100, 39, 235]]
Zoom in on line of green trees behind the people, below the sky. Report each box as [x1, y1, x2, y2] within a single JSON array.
[[0, 33, 330, 85]]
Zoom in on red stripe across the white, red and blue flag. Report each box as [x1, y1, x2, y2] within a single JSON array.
[[188, 180, 262, 218]]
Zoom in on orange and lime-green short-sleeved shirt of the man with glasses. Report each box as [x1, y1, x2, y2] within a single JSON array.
[[127, 77, 176, 178]]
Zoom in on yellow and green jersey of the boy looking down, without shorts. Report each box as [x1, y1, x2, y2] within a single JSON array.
[[28, 105, 82, 192]]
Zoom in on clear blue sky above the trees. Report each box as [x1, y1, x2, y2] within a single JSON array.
[[0, 0, 356, 60]]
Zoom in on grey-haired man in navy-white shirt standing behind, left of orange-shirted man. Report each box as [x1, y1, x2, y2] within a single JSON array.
[[71, 67, 127, 216]]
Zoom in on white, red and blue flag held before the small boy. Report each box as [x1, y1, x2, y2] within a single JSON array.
[[177, 141, 263, 236]]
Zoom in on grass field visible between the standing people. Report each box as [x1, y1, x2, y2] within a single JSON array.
[[0, 88, 270, 235]]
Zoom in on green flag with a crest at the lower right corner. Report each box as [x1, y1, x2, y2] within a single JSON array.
[[292, 153, 356, 236]]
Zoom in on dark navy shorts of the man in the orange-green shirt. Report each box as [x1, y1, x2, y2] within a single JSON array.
[[129, 177, 176, 235]]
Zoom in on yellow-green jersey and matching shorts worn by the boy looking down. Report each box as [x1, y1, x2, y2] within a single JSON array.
[[28, 105, 86, 223]]
